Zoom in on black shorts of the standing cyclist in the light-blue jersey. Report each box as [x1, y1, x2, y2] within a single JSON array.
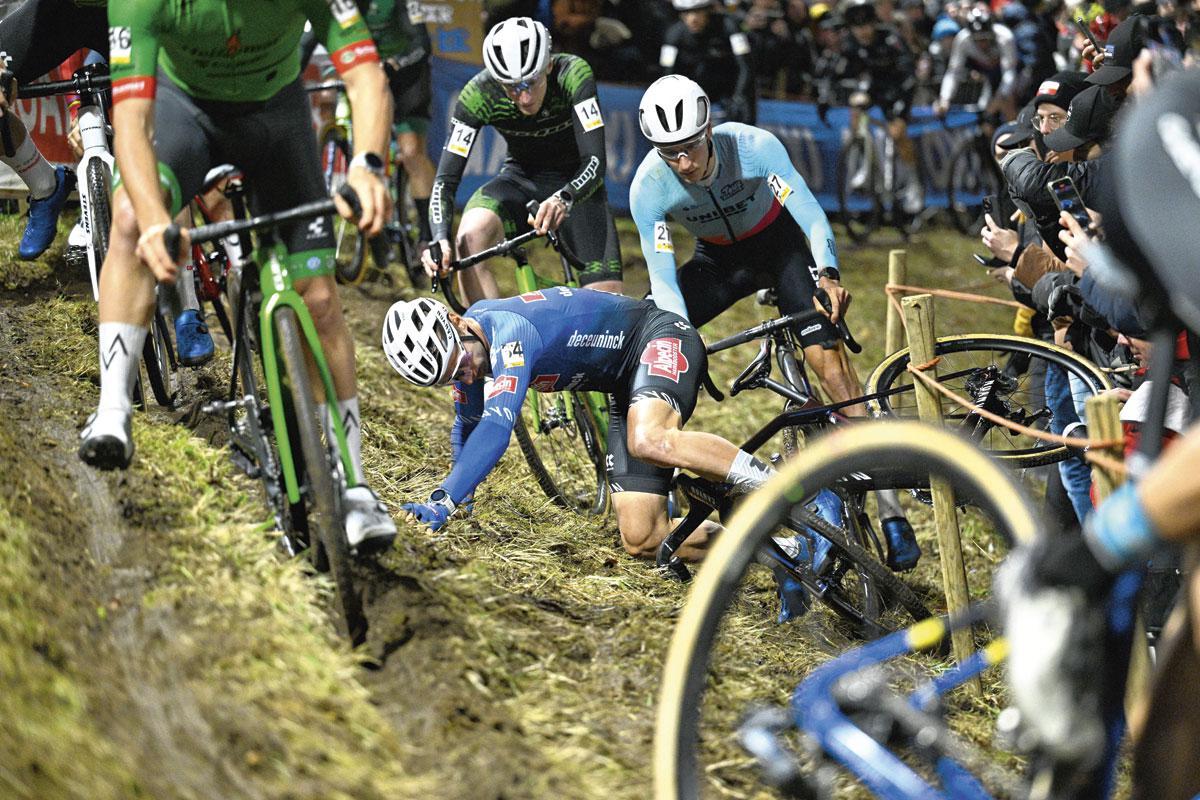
[[678, 211, 840, 349]]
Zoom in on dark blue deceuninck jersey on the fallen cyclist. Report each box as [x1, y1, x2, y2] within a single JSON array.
[[443, 287, 662, 503]]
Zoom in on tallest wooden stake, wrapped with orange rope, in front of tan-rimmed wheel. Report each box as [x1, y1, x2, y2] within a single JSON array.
[[900, 292, 983, 697]]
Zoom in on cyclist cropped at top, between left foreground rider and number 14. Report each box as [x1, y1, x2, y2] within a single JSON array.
[[362, 0, 433, 249]]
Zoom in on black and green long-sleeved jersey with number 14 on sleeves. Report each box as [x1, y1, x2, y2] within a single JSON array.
[[430, 53, 605, 239]]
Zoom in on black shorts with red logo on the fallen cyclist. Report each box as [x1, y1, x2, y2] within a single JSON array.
[[607, 309, 708, 497]]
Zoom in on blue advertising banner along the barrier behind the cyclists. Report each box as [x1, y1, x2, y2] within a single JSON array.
[[428, 58, 976, 212]]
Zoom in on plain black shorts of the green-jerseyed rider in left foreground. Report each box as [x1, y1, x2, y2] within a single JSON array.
[[155, 72, 334, 273]]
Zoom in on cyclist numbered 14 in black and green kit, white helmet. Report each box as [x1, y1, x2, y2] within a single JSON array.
[[422, 17, 622, 302]]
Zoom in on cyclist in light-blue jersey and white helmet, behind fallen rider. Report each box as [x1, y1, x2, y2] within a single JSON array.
[[629, 76, 920, 570]]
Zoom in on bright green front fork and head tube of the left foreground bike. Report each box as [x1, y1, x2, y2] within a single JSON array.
[[258, 245, 356, 503]]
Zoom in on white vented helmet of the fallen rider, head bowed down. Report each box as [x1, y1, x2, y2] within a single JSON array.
[[383, 297, 462, 386]]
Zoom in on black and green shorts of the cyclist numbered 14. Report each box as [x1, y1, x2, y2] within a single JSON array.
[[463, 164, 620, 287]]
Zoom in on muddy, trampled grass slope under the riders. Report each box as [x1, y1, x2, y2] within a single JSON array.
[[0, 215, 1032, 800]]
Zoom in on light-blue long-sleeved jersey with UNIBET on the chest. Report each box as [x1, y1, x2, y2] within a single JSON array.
[[629, 122, 838, 319]]
